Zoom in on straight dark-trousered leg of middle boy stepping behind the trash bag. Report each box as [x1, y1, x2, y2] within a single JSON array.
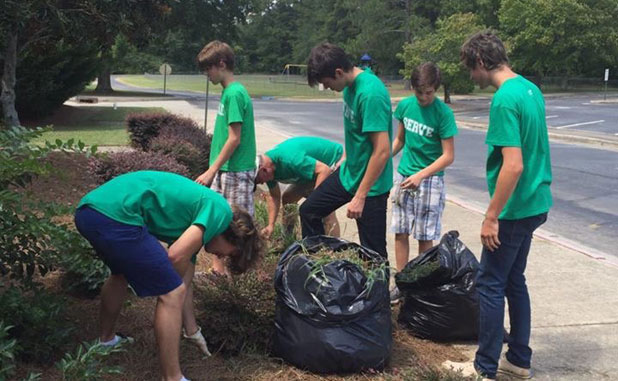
[[356, 192, 388, 259]]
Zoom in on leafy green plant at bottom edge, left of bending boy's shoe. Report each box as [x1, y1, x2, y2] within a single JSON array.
[[56, 340, 124, 381]]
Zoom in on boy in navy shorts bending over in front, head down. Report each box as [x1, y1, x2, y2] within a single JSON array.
[[75, 171, 262, 381]]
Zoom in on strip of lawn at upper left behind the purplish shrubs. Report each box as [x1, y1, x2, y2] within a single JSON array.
[[23, 106, 165, 146]]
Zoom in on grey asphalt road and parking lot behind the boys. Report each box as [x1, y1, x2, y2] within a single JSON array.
[[114, 78, 618, 257]]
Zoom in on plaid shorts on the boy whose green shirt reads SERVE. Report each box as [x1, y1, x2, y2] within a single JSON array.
[[391, 173, 445, 241]]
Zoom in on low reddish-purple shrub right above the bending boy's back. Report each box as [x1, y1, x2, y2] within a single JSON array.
[[88, 151, 189, 184]]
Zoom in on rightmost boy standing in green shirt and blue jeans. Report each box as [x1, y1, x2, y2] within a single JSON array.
[[461, 32, 552, 380]]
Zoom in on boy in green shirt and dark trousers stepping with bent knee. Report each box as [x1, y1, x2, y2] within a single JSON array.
[[300, 43, 393, 258]]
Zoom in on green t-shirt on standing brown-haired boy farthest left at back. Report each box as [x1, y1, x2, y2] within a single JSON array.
[[210, 82, 256, 172]]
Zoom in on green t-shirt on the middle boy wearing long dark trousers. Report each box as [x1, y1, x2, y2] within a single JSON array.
[[339, 71, 393, 196]]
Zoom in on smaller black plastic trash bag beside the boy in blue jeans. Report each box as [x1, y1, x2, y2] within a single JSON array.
[[395, 231, 479, 341]]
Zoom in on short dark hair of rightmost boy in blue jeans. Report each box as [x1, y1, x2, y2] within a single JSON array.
[[459, 30, 509, 70]]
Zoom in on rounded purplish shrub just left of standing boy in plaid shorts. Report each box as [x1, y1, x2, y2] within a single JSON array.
[[150, 136, 208, 178]]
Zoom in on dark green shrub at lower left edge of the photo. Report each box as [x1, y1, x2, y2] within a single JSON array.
[[0, 287, 72, 362]]
